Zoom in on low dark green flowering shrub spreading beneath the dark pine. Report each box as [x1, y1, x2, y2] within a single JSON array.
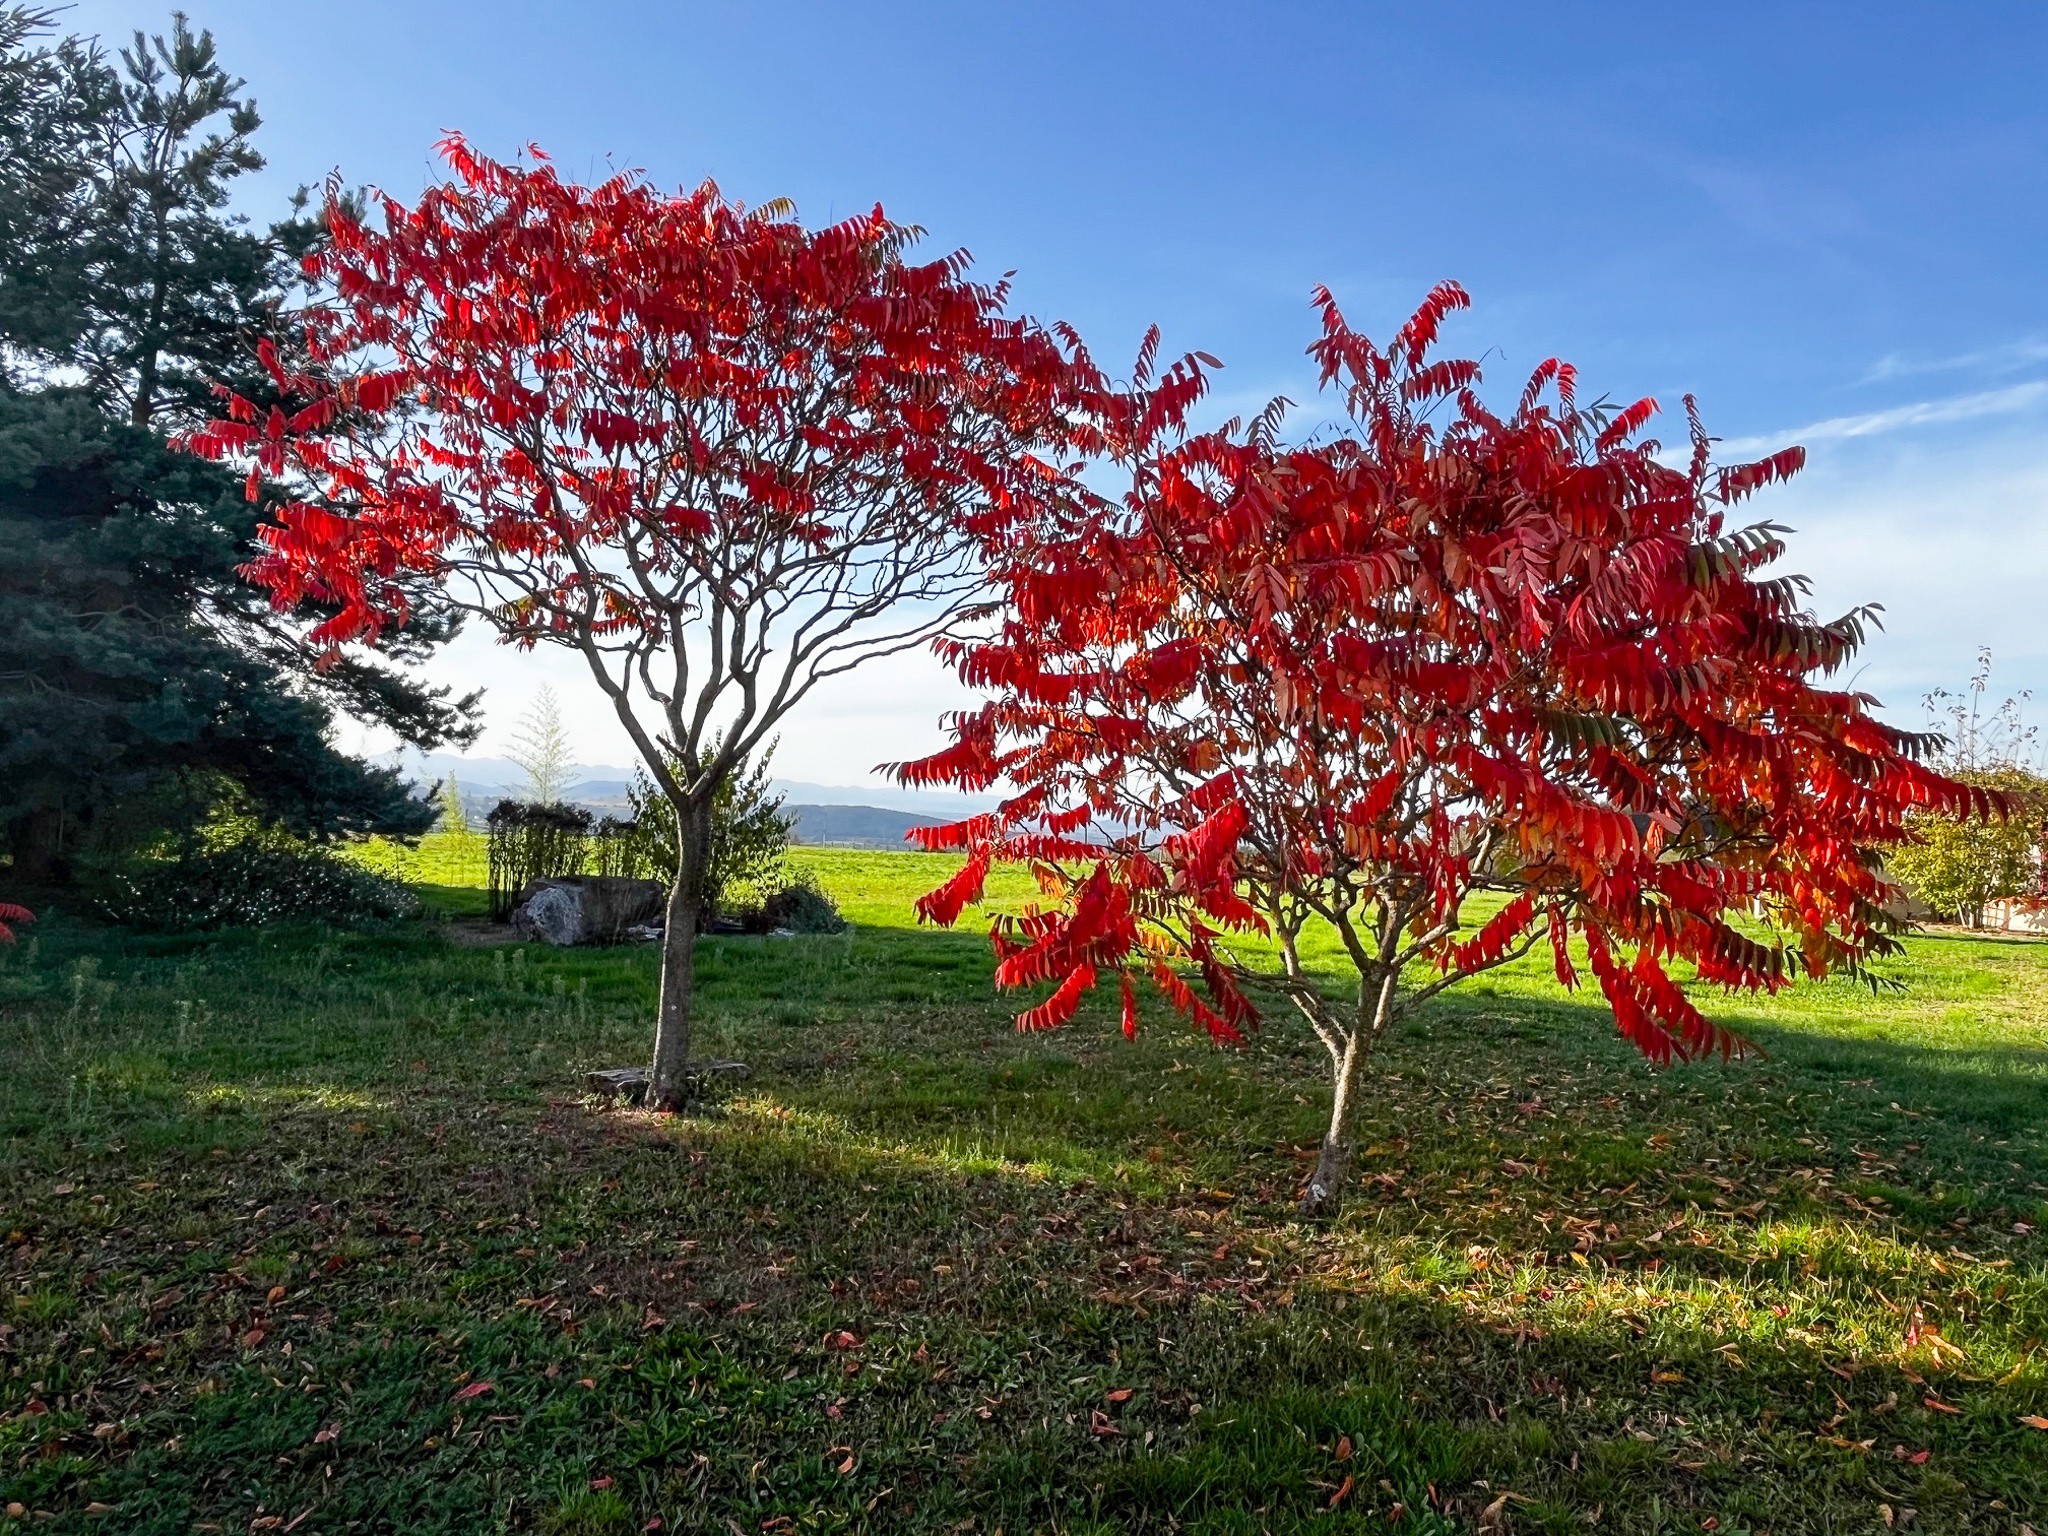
[[100, 836, 420, 930]]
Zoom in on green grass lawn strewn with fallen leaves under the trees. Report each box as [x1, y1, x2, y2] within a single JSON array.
[[0, 850, 2048, 1536]]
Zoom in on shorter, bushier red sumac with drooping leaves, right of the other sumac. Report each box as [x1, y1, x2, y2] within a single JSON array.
[[899, 285, 1989, 1212]]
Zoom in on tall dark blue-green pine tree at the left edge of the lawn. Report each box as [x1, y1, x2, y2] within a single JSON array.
[[0, 8, 473, 881]]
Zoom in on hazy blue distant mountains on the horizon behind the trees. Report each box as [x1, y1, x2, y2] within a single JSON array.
[[397, 752, 995, 848]]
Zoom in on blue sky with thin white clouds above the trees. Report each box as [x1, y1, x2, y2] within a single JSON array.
[[68, 0, 2048, 782]]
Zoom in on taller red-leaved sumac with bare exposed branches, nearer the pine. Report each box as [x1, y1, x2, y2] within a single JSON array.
[[190, 139, 1097, 1106]]
